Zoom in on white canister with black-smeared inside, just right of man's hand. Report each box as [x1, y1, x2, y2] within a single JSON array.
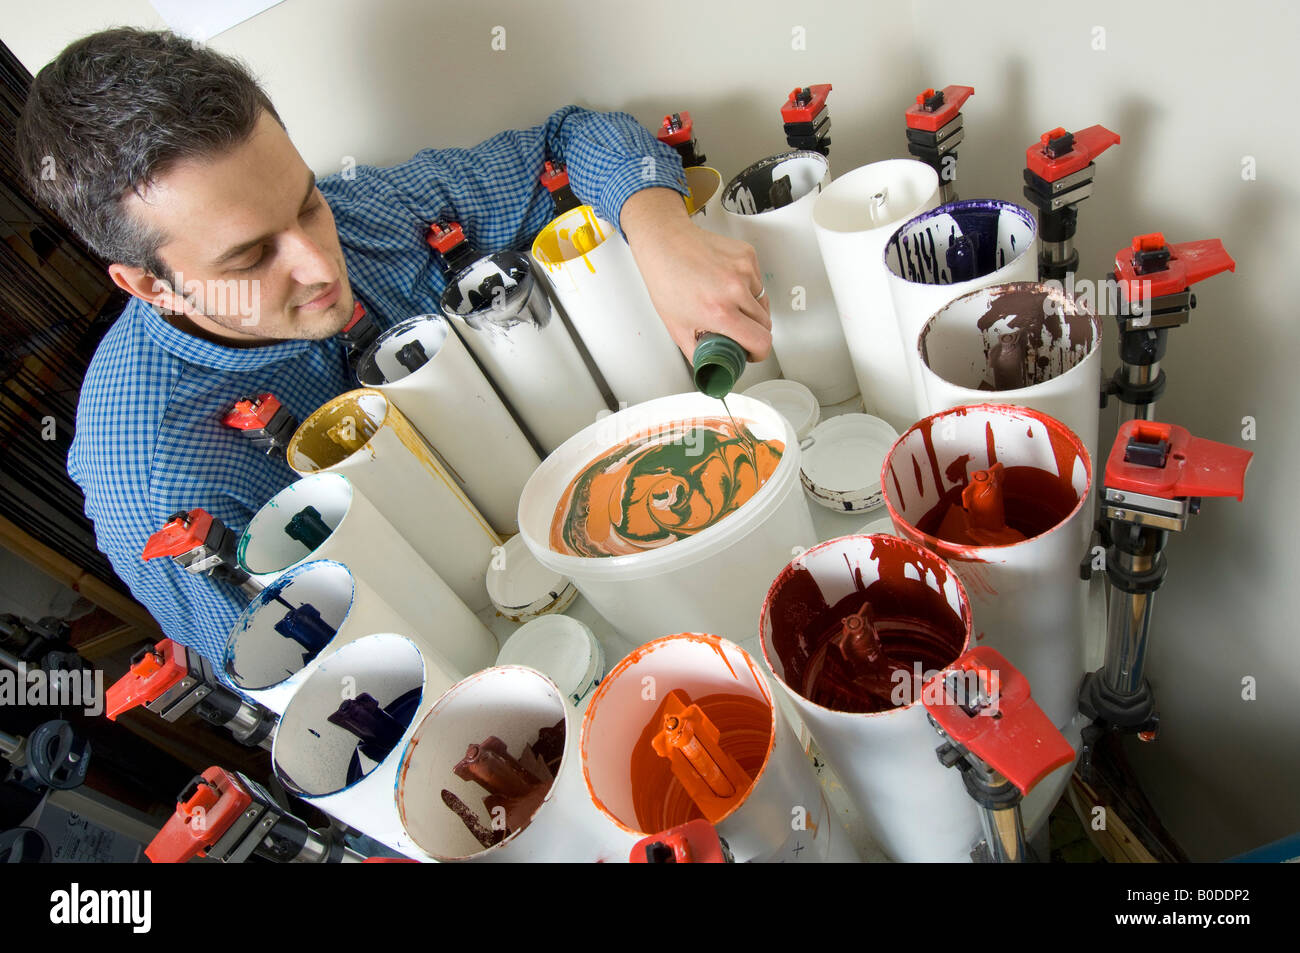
[[723, 152, 858, 407]]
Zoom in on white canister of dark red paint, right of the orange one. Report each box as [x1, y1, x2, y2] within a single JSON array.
[[759, 536, 980, 862]]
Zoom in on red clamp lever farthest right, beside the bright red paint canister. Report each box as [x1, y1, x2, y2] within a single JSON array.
[[1106, 420, 1255, 499]]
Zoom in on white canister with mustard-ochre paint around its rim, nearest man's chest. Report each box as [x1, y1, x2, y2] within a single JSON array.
[[285, 389, 501, 612]]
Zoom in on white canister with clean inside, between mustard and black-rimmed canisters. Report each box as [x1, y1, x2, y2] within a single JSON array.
[[356, 315, 541, 534]]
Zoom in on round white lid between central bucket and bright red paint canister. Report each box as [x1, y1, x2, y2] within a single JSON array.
[[800, 413, 898, 512]]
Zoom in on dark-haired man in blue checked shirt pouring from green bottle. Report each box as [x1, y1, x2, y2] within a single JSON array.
[[18, 29, 771, 659]]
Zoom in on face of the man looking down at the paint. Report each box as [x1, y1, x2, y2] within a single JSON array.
[[122, 112, 354, 346]]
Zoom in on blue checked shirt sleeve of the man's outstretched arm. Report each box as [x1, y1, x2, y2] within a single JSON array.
[[320, 105, 689, 324]]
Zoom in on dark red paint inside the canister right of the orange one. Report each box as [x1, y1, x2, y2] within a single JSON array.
[[770, 541, 966, 712]]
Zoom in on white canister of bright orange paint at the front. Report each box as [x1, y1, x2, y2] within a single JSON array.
[[582, 633, 857, 863]]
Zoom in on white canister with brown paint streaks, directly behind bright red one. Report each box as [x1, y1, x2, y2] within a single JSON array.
[[917, 281, 1101, 473]]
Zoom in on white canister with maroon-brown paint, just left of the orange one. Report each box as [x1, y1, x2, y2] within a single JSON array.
[[397, 666, 636, 863]]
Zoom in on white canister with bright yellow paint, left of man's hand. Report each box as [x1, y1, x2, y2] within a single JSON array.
[[533, 205, 694, 404]]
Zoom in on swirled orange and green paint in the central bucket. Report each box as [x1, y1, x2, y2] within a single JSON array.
[[550, 417, 785, 556]]
